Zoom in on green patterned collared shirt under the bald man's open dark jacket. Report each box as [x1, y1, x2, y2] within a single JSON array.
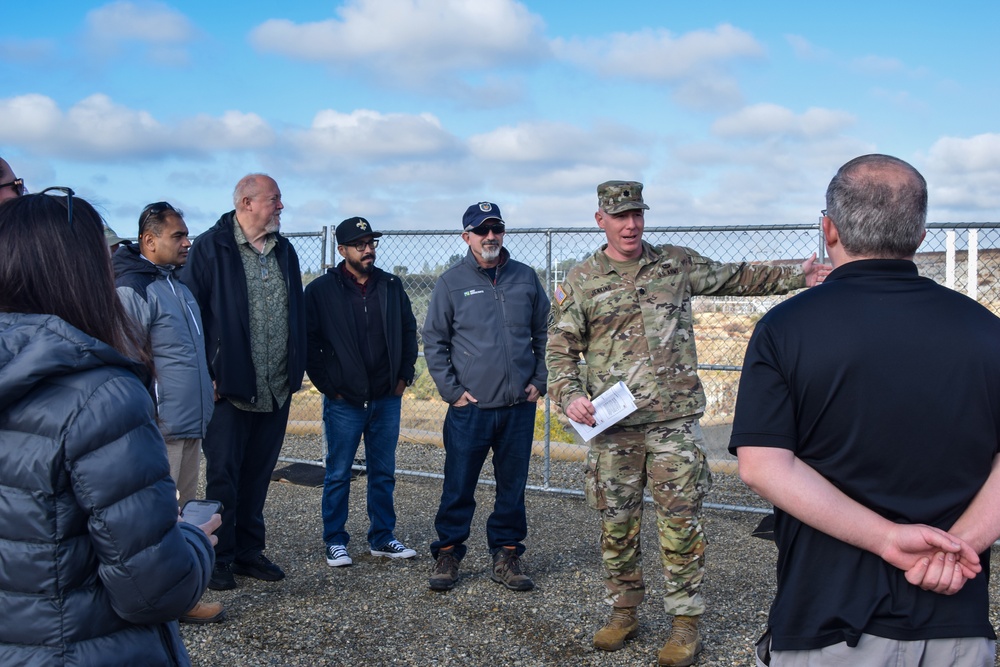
[[230, 216, 291, 412]]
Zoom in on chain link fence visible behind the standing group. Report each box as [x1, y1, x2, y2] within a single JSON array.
[[286, 223, 1000, 489]]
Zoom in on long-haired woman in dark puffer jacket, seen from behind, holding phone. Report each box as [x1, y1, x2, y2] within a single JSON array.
[[0, 191, 218, 665]]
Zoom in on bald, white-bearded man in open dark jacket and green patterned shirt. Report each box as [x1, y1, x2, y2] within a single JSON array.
[[181, 174, 306, 590]]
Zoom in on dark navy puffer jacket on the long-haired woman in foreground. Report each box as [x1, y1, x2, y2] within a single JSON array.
[[0, 313, 214, 665]]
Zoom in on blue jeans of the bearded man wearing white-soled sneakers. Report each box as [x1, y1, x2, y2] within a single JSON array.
[[323, 396, 402, 549]]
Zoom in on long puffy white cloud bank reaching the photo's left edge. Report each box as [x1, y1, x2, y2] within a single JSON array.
[[0, 94, 274, 160]]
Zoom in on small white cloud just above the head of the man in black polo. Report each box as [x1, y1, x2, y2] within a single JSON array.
[[712, 103, 854, 139]]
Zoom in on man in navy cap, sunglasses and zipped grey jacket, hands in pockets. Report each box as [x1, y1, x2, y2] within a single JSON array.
[[423, 202, 549, 591]]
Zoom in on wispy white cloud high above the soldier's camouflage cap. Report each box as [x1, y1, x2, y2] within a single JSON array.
[[552, 24, 764, 107]]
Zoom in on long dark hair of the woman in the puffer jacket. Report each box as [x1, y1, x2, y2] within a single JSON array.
[[0, 194, 152, 370]]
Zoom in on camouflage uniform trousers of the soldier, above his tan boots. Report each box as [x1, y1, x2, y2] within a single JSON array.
[[585, 418, 712, 616]]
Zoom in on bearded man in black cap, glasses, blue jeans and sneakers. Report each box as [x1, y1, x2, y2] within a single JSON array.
[[305, 217, 417, 567]]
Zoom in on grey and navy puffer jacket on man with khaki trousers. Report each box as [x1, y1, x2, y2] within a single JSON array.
[[114, 245, 215, 440]]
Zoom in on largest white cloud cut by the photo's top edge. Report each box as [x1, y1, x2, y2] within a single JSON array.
[[250, 0, 547, 87]]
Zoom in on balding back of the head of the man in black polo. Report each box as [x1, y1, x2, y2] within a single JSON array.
[[826, 154, 927, 259]]
